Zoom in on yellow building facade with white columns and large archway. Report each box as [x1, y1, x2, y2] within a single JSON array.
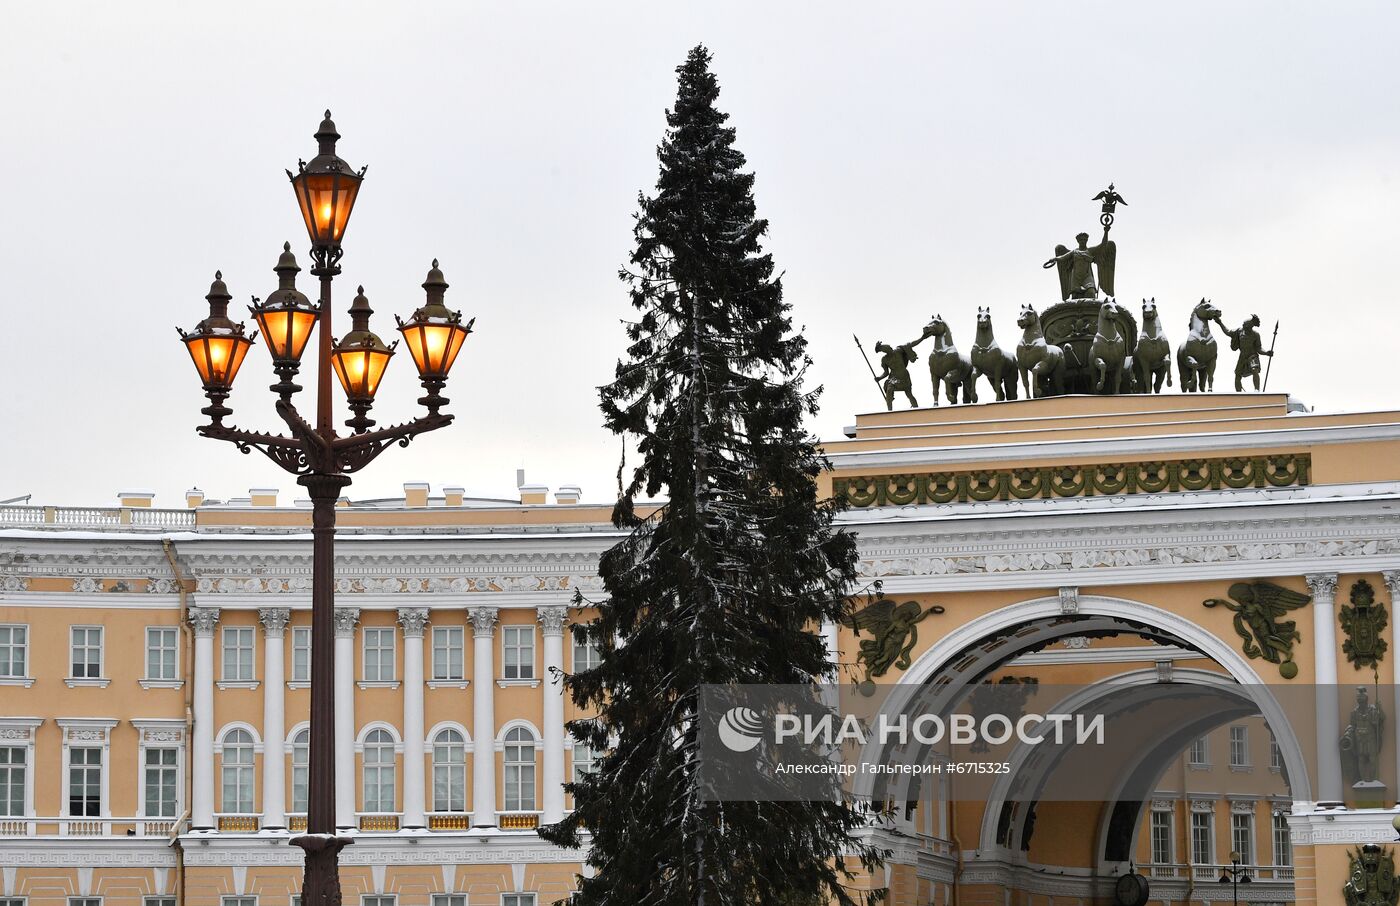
[[0, 393, 1400, 906]]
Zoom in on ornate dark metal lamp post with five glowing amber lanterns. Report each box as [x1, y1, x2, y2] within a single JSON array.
[[179, 111, 473, 906]]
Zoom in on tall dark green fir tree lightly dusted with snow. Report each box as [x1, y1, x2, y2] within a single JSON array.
[[540, 46, 879, 906]]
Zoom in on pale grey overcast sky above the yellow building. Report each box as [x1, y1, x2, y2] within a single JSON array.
[[0, 0, 1400, 506]]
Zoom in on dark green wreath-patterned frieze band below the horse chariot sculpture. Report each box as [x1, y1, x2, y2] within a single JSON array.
[[832, 452, 1312, 507]]
